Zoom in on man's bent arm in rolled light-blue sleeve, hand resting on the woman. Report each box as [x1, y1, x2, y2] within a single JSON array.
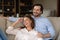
[[38, 19, 55, 38]]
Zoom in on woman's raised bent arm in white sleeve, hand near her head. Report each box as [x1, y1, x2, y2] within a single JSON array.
[[6, 18, 22, 35]]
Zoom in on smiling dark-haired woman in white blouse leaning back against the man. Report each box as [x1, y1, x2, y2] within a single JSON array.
[[6, 16, 43, 40]]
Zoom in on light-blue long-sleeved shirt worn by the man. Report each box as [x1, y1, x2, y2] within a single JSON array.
[[33, 16, 55, 40]]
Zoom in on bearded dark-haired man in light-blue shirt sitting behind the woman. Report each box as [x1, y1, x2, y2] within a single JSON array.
[[9, 4, 55, 40]]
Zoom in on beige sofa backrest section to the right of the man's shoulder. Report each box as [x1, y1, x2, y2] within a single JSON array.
[[48, 17, 60, 32]]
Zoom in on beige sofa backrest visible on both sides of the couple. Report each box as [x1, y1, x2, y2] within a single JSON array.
[[0, 17, 60, 40]]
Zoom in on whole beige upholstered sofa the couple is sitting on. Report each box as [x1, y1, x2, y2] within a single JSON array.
[[0, 17, 60, 40]]
